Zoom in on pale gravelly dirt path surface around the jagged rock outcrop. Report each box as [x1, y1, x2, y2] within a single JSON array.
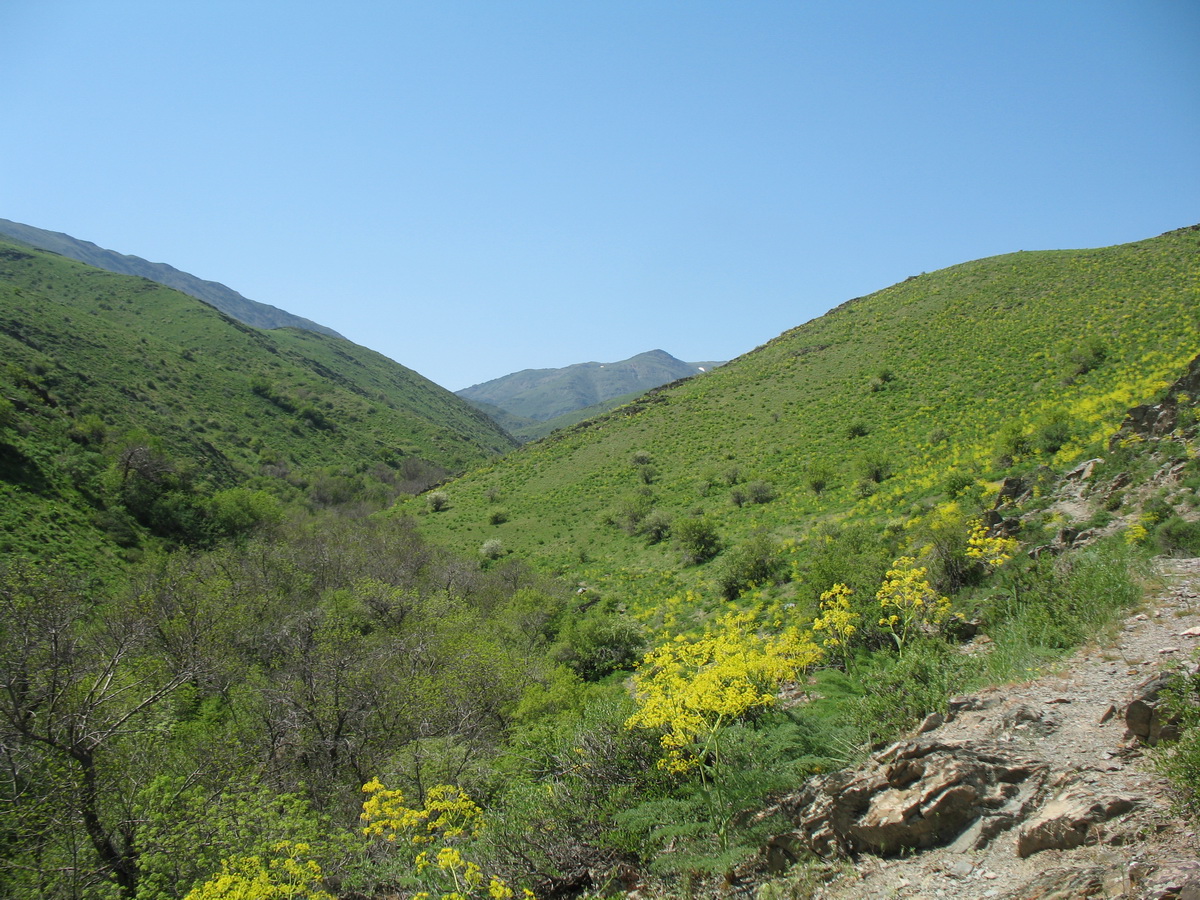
[[817, 559, 1200, 900]]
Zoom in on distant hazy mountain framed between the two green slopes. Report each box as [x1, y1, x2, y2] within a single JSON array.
[[457, 350, 721, 436]]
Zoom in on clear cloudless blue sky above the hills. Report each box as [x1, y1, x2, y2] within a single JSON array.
[[0, 0, 1200, 390]]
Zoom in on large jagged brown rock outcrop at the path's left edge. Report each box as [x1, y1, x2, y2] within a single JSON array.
[[772, 738, 1048, 857]]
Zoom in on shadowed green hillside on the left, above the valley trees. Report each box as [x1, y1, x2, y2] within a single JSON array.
[[0, 244, 512, 564]]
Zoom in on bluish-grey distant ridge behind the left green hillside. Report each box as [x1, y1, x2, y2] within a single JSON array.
[[0, 218, 341, 337]]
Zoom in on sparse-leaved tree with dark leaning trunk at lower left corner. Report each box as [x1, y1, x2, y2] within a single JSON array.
[[0, 565, 192, 898]]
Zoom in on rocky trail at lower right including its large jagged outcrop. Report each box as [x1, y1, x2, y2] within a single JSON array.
[[770, 559, 1200, 900]]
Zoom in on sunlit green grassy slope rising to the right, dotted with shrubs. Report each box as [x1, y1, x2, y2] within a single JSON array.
[[407, 229, 1200, 607]]
